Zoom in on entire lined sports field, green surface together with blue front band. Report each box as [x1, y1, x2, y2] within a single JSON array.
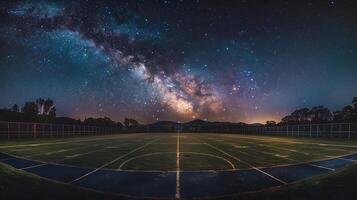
[[0, 133, 357, 198]]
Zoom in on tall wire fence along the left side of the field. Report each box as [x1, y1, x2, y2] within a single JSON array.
[[0, 122, 121, 139]]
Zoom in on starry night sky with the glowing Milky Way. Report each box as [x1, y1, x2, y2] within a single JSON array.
[[0, 0, 357, 123]]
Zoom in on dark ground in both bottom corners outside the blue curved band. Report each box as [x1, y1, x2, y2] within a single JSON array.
[[0, 163, 357, 200]]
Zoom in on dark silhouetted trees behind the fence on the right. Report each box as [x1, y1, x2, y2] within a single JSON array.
[[266, 97, 357, 125]]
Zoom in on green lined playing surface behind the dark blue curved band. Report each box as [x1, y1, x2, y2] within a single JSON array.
[[0, 133, 357, 171]]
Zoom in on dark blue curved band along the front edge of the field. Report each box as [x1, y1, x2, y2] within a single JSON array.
[[0, 153, 357, 199]]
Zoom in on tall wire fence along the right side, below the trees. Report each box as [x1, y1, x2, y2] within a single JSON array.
[[239, 123, 357, 139]]
